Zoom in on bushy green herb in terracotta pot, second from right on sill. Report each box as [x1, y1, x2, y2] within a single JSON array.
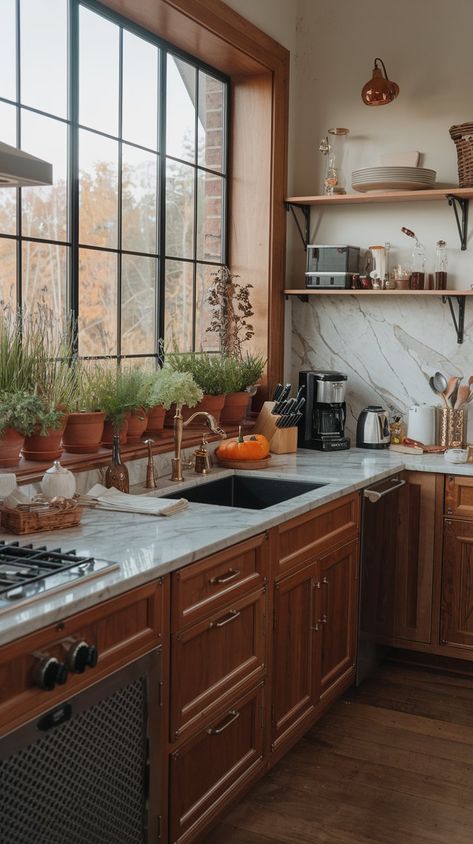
[[166, 352, 229, 426]]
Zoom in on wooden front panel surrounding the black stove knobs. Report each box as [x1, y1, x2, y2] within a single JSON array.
[[0, 579, 169, 729]]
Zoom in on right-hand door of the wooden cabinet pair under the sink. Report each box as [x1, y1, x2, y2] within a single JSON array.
[[317, 542, 358, 696]]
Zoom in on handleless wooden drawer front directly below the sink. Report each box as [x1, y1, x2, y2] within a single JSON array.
[[276, 493, 360, 577]]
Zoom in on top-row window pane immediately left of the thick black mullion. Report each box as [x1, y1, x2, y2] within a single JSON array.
[[20, 0, 67, 117]]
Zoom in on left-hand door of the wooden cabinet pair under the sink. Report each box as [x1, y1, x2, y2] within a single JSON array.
[[271, 563, 319, 746]]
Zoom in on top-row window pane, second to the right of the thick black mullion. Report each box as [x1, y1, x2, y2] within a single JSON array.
[[123, 30, 159, 149]]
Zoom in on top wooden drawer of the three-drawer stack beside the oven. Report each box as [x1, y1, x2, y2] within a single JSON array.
[[172, 534, 268, 631]]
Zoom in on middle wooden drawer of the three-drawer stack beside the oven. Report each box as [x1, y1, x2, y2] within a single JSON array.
[[171, 587, 266, 740]]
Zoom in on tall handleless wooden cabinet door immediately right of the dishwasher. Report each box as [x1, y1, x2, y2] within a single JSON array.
[[394, 472, 437, 643]]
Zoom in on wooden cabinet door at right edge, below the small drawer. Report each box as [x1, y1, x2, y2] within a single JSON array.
[[440, 519, 473, 648]]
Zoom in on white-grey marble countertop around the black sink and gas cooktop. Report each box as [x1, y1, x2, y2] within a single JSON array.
[[0, 449, 473, 644]]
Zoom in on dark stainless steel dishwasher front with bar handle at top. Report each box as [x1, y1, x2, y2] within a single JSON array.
[[356, 475, 405, 686]]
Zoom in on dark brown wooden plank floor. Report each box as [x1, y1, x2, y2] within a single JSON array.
[[205, 663, 473, 844]]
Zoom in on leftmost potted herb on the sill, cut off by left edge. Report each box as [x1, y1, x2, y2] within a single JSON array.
[[0, 390, 43, 468]]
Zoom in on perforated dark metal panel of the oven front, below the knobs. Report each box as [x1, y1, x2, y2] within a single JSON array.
[[0, 676, 147, 844]]
